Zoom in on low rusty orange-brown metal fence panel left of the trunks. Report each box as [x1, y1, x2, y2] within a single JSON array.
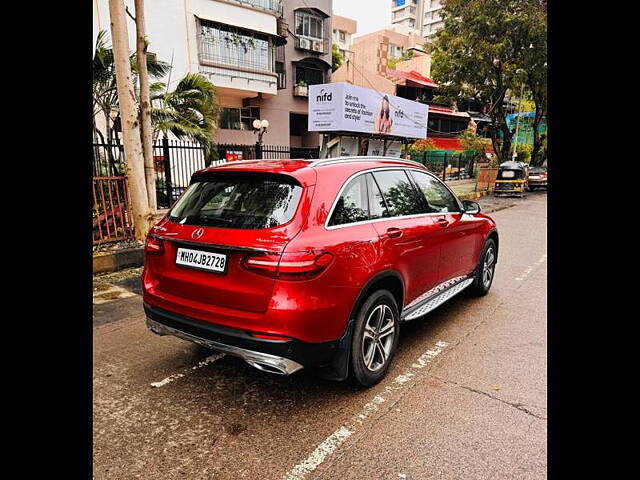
[[93, 176, 133, 245]]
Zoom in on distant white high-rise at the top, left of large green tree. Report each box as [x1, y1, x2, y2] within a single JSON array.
[[391, 0, 444, 40]]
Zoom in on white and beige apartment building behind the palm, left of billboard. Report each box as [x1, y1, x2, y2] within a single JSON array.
[[94, 0, 333, 147]]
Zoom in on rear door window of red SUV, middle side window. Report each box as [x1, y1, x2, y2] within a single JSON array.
[[373, 170, 426, 217]]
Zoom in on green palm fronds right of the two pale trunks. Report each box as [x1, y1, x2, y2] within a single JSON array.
[[151, 73, 219, 162]]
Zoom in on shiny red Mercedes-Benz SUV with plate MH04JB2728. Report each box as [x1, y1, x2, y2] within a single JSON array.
[[142, 157, 499, 385]]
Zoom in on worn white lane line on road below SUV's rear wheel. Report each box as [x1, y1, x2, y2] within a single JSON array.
[[283, 341, 448, 480]]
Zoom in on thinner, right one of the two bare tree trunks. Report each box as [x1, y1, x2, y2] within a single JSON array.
[[135, 0, 158, 213]]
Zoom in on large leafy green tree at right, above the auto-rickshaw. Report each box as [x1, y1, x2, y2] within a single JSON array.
[[430, 0, 546, 162]]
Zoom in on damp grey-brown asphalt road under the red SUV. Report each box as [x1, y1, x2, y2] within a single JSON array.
[[93, 193, 547, 480]]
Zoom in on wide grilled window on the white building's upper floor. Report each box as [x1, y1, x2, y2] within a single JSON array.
[[200, 20, 276, 72]]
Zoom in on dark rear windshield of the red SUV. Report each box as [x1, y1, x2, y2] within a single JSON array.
[[169, 172, 302, 230]]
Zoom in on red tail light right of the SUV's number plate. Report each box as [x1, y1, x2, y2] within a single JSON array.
[[242, 251, 333, 280]]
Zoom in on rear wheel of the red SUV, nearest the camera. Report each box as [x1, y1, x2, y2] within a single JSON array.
[[351, 290, 400, 387]]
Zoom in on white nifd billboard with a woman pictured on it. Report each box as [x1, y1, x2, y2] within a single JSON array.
[[309, 83, 428, 138]]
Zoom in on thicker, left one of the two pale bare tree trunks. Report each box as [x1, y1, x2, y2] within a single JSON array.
[[109, 0, 153, 241]]
